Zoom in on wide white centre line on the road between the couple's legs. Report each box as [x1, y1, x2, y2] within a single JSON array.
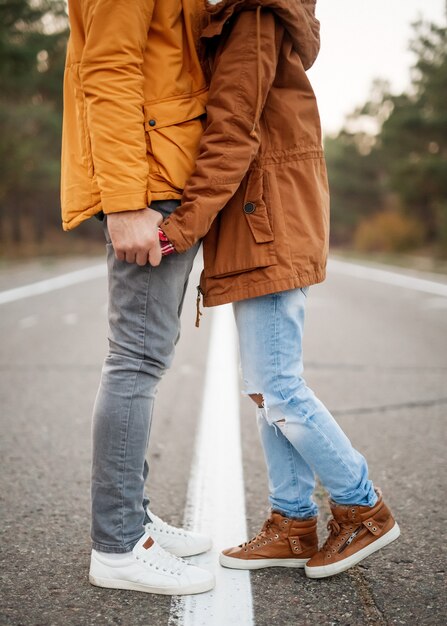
[[169, 305, 253, 626]]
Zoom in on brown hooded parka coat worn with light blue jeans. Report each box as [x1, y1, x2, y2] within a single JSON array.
[[162, 0, 329, 306]]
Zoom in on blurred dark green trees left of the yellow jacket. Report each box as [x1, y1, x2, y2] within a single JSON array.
[[0, 0, 68, 243]]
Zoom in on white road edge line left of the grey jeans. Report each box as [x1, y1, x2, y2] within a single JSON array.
[[0, 263, 107, 304]]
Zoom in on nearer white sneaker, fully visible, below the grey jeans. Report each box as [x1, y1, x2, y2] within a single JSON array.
[[89, 533, 215, 595]]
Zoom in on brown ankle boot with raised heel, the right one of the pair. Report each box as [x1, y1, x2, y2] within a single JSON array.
[[305, 491, 400, 578]]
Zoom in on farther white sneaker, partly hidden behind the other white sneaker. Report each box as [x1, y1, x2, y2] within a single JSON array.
[[144, 507, 212, 556]]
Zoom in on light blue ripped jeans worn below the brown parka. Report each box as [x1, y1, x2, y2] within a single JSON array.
[[233, 287, 377, 518]]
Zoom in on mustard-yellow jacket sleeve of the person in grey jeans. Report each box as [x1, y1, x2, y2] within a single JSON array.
[[79, 0, 154, 213]]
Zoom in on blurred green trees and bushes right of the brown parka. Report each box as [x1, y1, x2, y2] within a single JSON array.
[[327, 17, 447, 255]]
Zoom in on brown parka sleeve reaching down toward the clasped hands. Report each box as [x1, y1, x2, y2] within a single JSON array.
[[161, 10, 283, 252]]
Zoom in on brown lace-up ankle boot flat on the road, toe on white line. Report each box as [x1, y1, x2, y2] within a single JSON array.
[[219, 511, 318, 569]]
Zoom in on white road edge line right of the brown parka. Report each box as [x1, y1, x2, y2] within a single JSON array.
[[328, 259, 447, 297]]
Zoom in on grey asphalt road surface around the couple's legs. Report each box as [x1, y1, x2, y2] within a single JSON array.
[[0, 258, 447, 626]]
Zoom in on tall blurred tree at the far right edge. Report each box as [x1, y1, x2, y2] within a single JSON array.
[[380, 22, 447, 246]]
